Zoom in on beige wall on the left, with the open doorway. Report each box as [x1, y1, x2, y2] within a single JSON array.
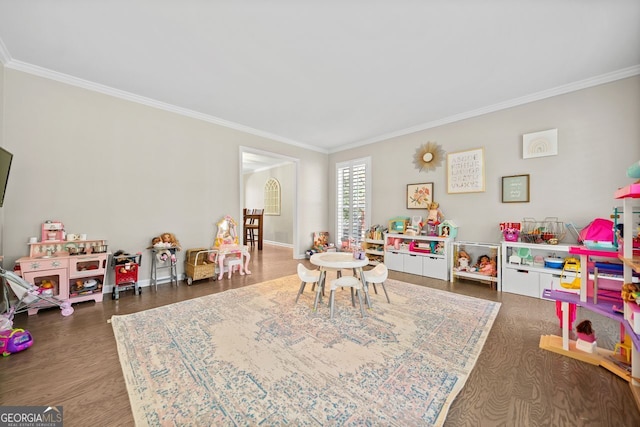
[[2, 69, 328, 280]]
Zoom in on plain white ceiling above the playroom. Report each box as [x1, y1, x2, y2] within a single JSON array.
[[0, 0, 640, 152]]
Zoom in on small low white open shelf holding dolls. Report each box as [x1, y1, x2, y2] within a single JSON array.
[[449, 242, 502, 290]]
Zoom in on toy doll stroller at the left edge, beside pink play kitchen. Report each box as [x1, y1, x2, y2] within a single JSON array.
[[0, 268, 73, 316]]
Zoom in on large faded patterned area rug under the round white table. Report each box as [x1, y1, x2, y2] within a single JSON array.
[[111, 275, 500, 426]]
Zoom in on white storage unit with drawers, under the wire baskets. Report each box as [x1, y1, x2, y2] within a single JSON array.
[[501, 241, 579, 298]]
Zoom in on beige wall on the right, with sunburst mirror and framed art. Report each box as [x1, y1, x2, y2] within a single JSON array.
[[329, 77, 640, 242]]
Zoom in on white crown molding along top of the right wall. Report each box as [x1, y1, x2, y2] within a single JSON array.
[[336, 65, 640, 153]]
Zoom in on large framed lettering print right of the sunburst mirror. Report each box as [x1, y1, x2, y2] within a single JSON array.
[[447, 148, 484, 194]]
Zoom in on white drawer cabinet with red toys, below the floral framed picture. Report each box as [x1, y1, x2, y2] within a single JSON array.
[[384, 233, 453, 280]]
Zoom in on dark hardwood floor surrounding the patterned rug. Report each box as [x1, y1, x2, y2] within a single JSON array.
[[0, 244, 640, 427]]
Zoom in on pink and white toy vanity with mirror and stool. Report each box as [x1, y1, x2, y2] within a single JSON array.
[[214, 215, 251, 280]]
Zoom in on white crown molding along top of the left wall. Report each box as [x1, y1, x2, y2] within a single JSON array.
[[0, 59, 328, 154]]
